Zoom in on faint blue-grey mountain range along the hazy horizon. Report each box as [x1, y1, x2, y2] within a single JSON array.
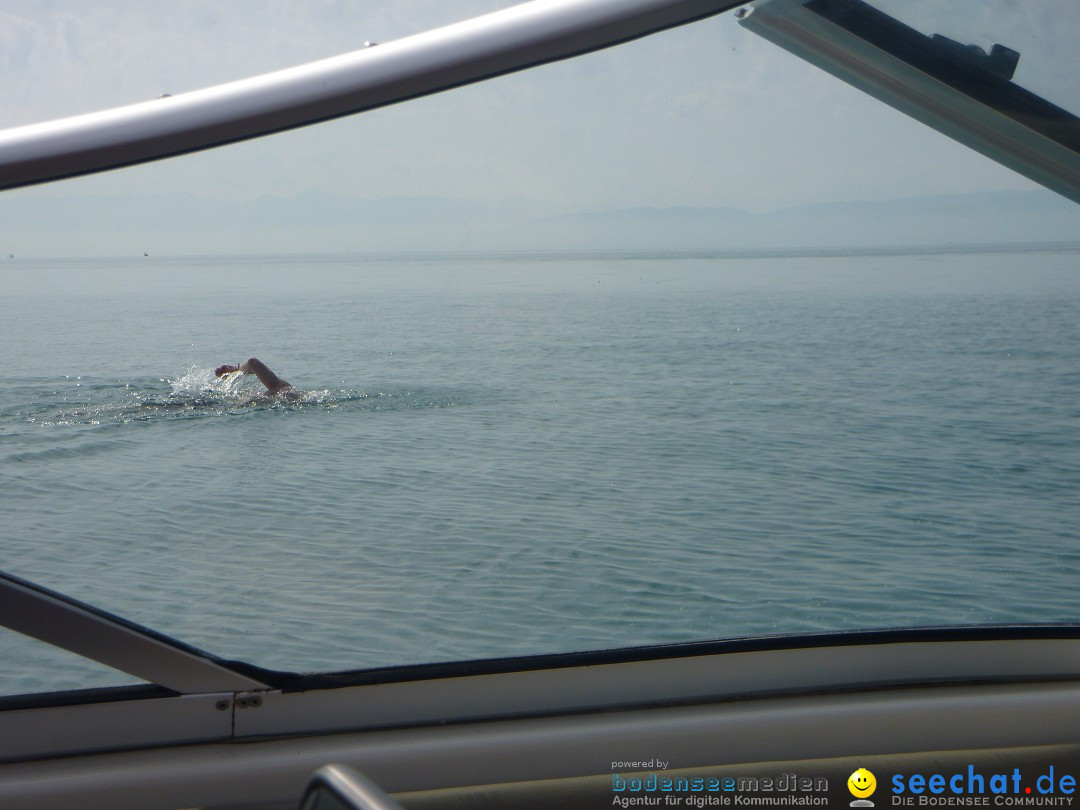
[[0, 191, 1080, 257]]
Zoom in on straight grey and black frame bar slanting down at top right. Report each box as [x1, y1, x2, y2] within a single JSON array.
[[739, 0, 1080, 203]]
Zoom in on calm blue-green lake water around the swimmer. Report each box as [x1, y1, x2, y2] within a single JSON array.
[[0, 247, 1080, 693]]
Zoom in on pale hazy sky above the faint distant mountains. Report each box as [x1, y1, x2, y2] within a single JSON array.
[[0, 0, 1077, 216]]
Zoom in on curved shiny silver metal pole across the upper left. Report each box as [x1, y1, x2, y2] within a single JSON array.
[[0, 0, 741, 189]]
